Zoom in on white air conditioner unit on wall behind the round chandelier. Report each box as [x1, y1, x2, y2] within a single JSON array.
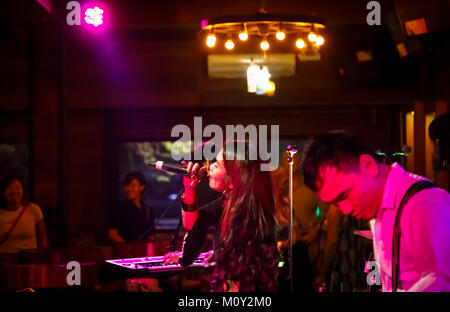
[[208, 54, 295, 78]]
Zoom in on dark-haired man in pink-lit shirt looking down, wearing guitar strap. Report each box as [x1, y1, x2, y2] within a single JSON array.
[[302, 132, 450, 291]]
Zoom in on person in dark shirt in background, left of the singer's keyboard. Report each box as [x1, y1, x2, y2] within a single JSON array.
[[108, 172, 154, 243]]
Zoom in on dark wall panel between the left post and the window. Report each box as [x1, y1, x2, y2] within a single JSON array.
[[68, 113, 108, 244]]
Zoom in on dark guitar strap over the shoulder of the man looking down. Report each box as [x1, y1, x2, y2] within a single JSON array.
[[392, 180, 436, 292]]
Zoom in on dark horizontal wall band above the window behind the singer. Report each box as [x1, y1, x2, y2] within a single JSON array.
[[113, 108, 395, 148]]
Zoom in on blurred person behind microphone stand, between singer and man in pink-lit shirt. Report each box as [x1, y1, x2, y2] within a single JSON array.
[[272, 153, 342, 292]]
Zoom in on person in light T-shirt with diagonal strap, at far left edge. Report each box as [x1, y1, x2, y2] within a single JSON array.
[[0, 176, 48, 253]]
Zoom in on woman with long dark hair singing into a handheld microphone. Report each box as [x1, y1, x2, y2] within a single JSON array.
[[170, 142, 279, 292]]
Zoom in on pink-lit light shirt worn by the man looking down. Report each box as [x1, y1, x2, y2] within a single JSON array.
[[371, 163, 450, 291]]
